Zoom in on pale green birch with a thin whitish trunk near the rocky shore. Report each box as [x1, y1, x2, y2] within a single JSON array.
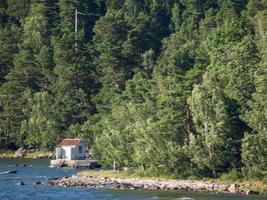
[[188, 72, 236, 177]]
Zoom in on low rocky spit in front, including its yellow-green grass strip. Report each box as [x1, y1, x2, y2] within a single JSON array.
[[48, 170, 267, 195]]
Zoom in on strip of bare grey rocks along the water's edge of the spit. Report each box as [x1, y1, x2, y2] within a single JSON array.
[[48, 175, 258, 194]]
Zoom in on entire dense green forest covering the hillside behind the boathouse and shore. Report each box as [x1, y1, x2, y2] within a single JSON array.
[[0, 0, 267, 179]]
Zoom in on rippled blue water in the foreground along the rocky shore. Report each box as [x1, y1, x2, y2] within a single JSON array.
[[0, 159, 267, 200]]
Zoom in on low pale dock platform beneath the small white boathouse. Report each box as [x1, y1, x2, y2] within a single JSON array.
[[50, 159, 100, 169]]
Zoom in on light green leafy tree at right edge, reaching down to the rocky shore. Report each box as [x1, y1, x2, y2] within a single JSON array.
[[242, 65, 267, 178]]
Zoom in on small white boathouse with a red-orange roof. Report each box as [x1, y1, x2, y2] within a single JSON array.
[[56, 138, 87, 160]]
